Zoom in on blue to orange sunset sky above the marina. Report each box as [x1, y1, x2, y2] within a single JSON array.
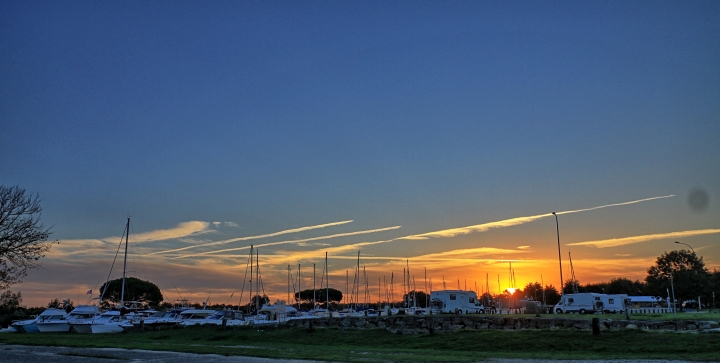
[[0, 0, 720, 306]]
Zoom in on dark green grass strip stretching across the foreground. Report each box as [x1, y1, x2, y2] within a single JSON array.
[[0, 327, 720, 362]]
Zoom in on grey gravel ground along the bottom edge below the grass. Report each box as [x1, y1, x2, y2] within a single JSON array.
[[0, 344, 704, 363]]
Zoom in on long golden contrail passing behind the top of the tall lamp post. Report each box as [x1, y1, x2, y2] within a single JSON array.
[[398, 195, 675, 240]]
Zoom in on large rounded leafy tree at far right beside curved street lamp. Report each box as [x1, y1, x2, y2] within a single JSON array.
[[645, 250, 711, 308]]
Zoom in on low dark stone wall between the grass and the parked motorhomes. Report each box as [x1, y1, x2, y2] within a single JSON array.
[[285, 315, 720, 334]]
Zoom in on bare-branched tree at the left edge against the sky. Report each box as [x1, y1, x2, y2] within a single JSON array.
[[0, 185, 57, 290]]
